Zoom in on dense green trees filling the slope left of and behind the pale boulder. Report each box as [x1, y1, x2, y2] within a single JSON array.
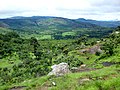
[[0, 32, 86, 85]]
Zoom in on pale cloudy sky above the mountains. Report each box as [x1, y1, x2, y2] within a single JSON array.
[[0, 0, 120, 20]]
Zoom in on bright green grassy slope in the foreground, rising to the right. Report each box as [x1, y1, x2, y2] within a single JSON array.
[[0, 46, 120, 90]]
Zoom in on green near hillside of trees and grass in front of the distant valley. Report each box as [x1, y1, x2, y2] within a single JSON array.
[[0, 27, 120, 90]]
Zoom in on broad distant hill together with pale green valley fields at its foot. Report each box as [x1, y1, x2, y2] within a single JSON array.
[[0, 16, 113, 39]]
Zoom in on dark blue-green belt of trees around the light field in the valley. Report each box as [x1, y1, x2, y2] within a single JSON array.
[[52, 28, 113, 40]]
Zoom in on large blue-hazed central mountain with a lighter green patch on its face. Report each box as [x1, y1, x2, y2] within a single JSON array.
[[0, 16, 99, 30]]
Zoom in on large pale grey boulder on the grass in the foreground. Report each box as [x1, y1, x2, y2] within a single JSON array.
[[48, 62, 70, 76]]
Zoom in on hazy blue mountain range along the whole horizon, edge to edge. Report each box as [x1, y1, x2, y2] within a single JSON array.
[[0, 16, 120, 29]]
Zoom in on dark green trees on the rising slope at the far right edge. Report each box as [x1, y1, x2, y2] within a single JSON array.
[[101, 26, 120, 58]]
